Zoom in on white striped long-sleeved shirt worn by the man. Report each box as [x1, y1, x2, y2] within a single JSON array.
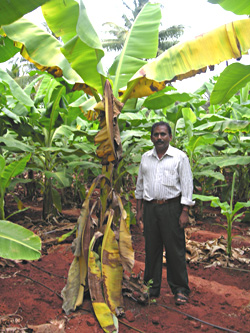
[[135, 145, 195, 206]]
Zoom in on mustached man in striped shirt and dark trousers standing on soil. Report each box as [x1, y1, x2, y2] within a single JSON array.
[[135, 121, 194, 305]]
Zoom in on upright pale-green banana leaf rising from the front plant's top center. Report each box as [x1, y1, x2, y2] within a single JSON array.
[[110, 3, 161, 97]]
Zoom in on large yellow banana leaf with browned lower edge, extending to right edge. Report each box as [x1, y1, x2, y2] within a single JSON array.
[[120, 19, 250, 101]]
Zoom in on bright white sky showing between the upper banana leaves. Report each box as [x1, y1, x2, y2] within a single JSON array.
[[2, 0, 250, 92]]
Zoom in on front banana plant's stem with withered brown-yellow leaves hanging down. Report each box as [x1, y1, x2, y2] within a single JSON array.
[[62, 81, 138, 332]]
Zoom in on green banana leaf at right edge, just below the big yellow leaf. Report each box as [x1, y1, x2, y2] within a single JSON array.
[[210, 63, 250, 104]]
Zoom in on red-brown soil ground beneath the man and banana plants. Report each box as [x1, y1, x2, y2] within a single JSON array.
[[0, 200, 250, 333]]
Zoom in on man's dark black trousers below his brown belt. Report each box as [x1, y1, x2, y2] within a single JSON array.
[[143, 201, 190, 296]]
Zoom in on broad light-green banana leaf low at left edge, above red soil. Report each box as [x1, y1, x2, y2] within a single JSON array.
[[0, 220, 41, 260]]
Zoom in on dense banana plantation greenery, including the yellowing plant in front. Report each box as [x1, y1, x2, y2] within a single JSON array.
[[0, 0, 250, 332]]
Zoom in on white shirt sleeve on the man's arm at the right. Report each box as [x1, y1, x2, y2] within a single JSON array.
[[179, 155, 195, 206]]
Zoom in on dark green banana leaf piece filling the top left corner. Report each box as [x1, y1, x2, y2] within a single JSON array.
[[0, 0, 48, 27]]
